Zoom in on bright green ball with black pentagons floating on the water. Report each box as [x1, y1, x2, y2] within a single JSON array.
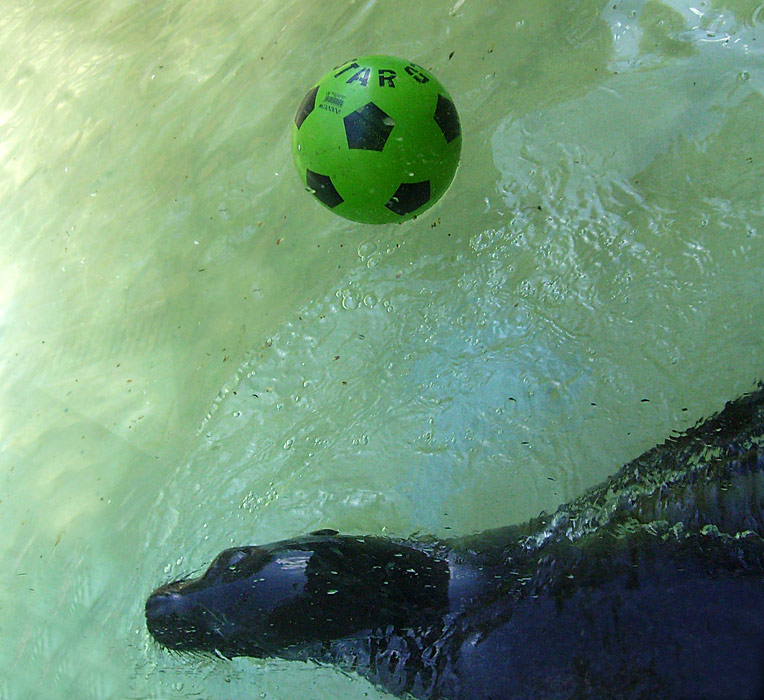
[[292, 56, 462, 224]]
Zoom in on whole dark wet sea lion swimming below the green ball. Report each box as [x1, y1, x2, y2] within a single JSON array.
[[146, 385, 764, 700]]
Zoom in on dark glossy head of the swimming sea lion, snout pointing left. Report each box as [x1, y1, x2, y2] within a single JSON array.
[[146, 530, 449, 657]]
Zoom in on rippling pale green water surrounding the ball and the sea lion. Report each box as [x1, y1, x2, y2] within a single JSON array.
[[0, 0, 764, 700]]
